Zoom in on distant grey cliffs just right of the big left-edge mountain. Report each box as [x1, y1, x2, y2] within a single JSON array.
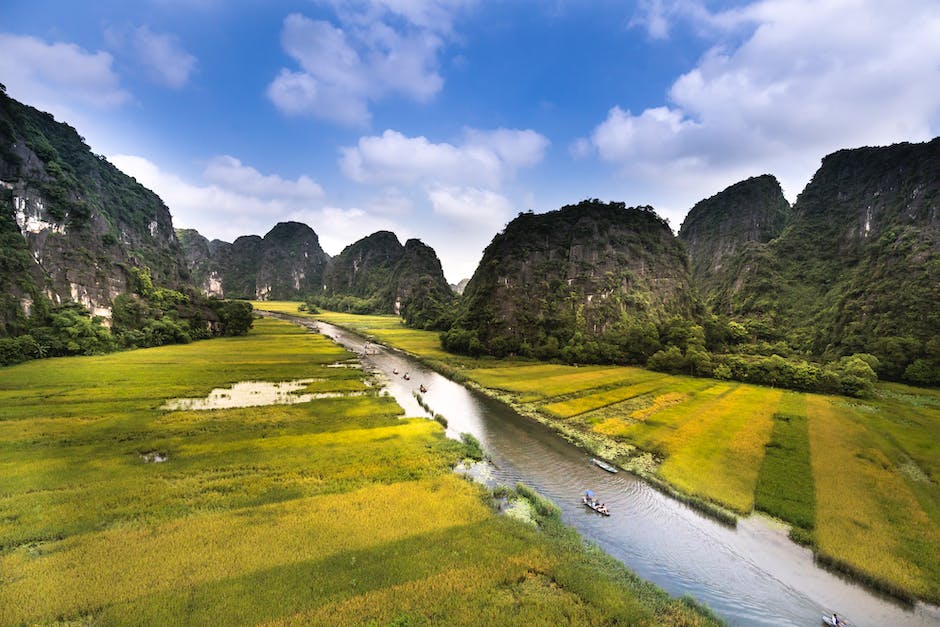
[[179, 222, 330, 300]]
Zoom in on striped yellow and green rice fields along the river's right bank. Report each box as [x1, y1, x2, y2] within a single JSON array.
[[261, 303, 940, 603]]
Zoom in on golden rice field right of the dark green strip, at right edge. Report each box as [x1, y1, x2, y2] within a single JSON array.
[[806, 396, 940, 601]]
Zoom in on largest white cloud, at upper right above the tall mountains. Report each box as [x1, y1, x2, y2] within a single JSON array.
[[581, 0, 940, 216]]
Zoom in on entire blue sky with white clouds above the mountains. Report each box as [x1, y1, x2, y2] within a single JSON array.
[[0, 0, 940, 283]]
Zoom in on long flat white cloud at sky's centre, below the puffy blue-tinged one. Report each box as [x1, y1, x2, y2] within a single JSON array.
[[340, 129, 549, 187]]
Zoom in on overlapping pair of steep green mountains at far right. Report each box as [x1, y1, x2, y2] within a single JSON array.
[[680, 138, 940, 393]]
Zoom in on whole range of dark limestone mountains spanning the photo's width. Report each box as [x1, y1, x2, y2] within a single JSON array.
[[0, 94, 940, 383]]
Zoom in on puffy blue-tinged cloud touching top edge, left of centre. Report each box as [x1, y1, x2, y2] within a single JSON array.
[[267, 0, 467, 125]]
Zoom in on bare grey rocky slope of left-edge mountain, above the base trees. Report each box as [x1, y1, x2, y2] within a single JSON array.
[[0, 94, 186, 332]]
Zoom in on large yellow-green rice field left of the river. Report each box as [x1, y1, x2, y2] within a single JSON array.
[[0, 320, 714, 625]]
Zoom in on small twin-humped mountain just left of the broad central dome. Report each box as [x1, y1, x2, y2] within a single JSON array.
[[314, 231, 455, 328]]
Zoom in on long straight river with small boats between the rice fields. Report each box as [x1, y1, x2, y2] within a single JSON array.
[[294, 319, 940, 626]]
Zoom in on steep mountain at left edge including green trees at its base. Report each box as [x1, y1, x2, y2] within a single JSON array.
[[0, 90, 252, 365]]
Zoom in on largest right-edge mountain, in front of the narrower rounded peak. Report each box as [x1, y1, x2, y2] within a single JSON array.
[[683, 138, 940, 375]]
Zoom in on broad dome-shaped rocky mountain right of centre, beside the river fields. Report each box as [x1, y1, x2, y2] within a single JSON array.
[[457, 201, 698, 352]]
